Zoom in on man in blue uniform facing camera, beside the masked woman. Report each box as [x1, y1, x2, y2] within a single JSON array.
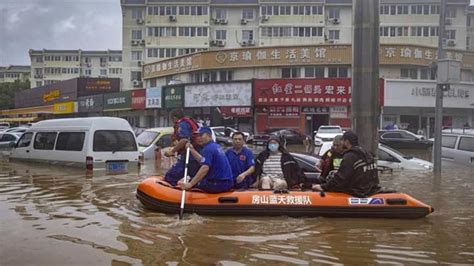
[[225, 131, 255, 189]]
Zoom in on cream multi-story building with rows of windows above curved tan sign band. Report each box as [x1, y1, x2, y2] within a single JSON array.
[[121, 0, 474, 89]]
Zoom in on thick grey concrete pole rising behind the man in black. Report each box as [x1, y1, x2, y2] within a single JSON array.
[[351, 0, 380, 154]]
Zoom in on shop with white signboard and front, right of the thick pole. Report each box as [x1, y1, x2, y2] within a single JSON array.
[[381, 80, 474, 137]]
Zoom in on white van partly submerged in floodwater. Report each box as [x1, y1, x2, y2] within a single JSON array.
[[10, 117, 140, 174]]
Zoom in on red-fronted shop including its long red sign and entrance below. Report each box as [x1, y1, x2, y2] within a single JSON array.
[[254, 78, 383, 134]]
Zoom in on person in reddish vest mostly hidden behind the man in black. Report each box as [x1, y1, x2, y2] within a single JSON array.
[[316, 135, 344, 180]]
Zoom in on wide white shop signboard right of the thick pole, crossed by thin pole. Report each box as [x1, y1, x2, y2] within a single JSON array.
[[384, 80, 474, 109]]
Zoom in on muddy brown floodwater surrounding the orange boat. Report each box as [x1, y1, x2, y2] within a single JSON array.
[[0, 147, 474, 265]]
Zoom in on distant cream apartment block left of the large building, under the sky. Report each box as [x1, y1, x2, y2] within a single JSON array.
[[29, 50, 122, 88]]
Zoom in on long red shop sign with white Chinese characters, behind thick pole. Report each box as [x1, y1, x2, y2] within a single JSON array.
[[254, 78, 384, 106]]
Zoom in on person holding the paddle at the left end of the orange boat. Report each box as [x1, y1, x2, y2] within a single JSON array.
[[165, 109, 200, 186]]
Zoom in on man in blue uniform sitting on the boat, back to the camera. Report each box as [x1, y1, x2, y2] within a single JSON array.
[[178, 127, 234, 193]]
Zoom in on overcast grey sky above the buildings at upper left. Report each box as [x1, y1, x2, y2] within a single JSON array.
[[0, 0, 474, 66]]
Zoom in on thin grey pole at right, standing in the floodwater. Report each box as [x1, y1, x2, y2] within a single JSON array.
[[433, 0, 449, 178]]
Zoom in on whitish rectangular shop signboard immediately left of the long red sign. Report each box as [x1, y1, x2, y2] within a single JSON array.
[[184, 82, 252, 107]]
